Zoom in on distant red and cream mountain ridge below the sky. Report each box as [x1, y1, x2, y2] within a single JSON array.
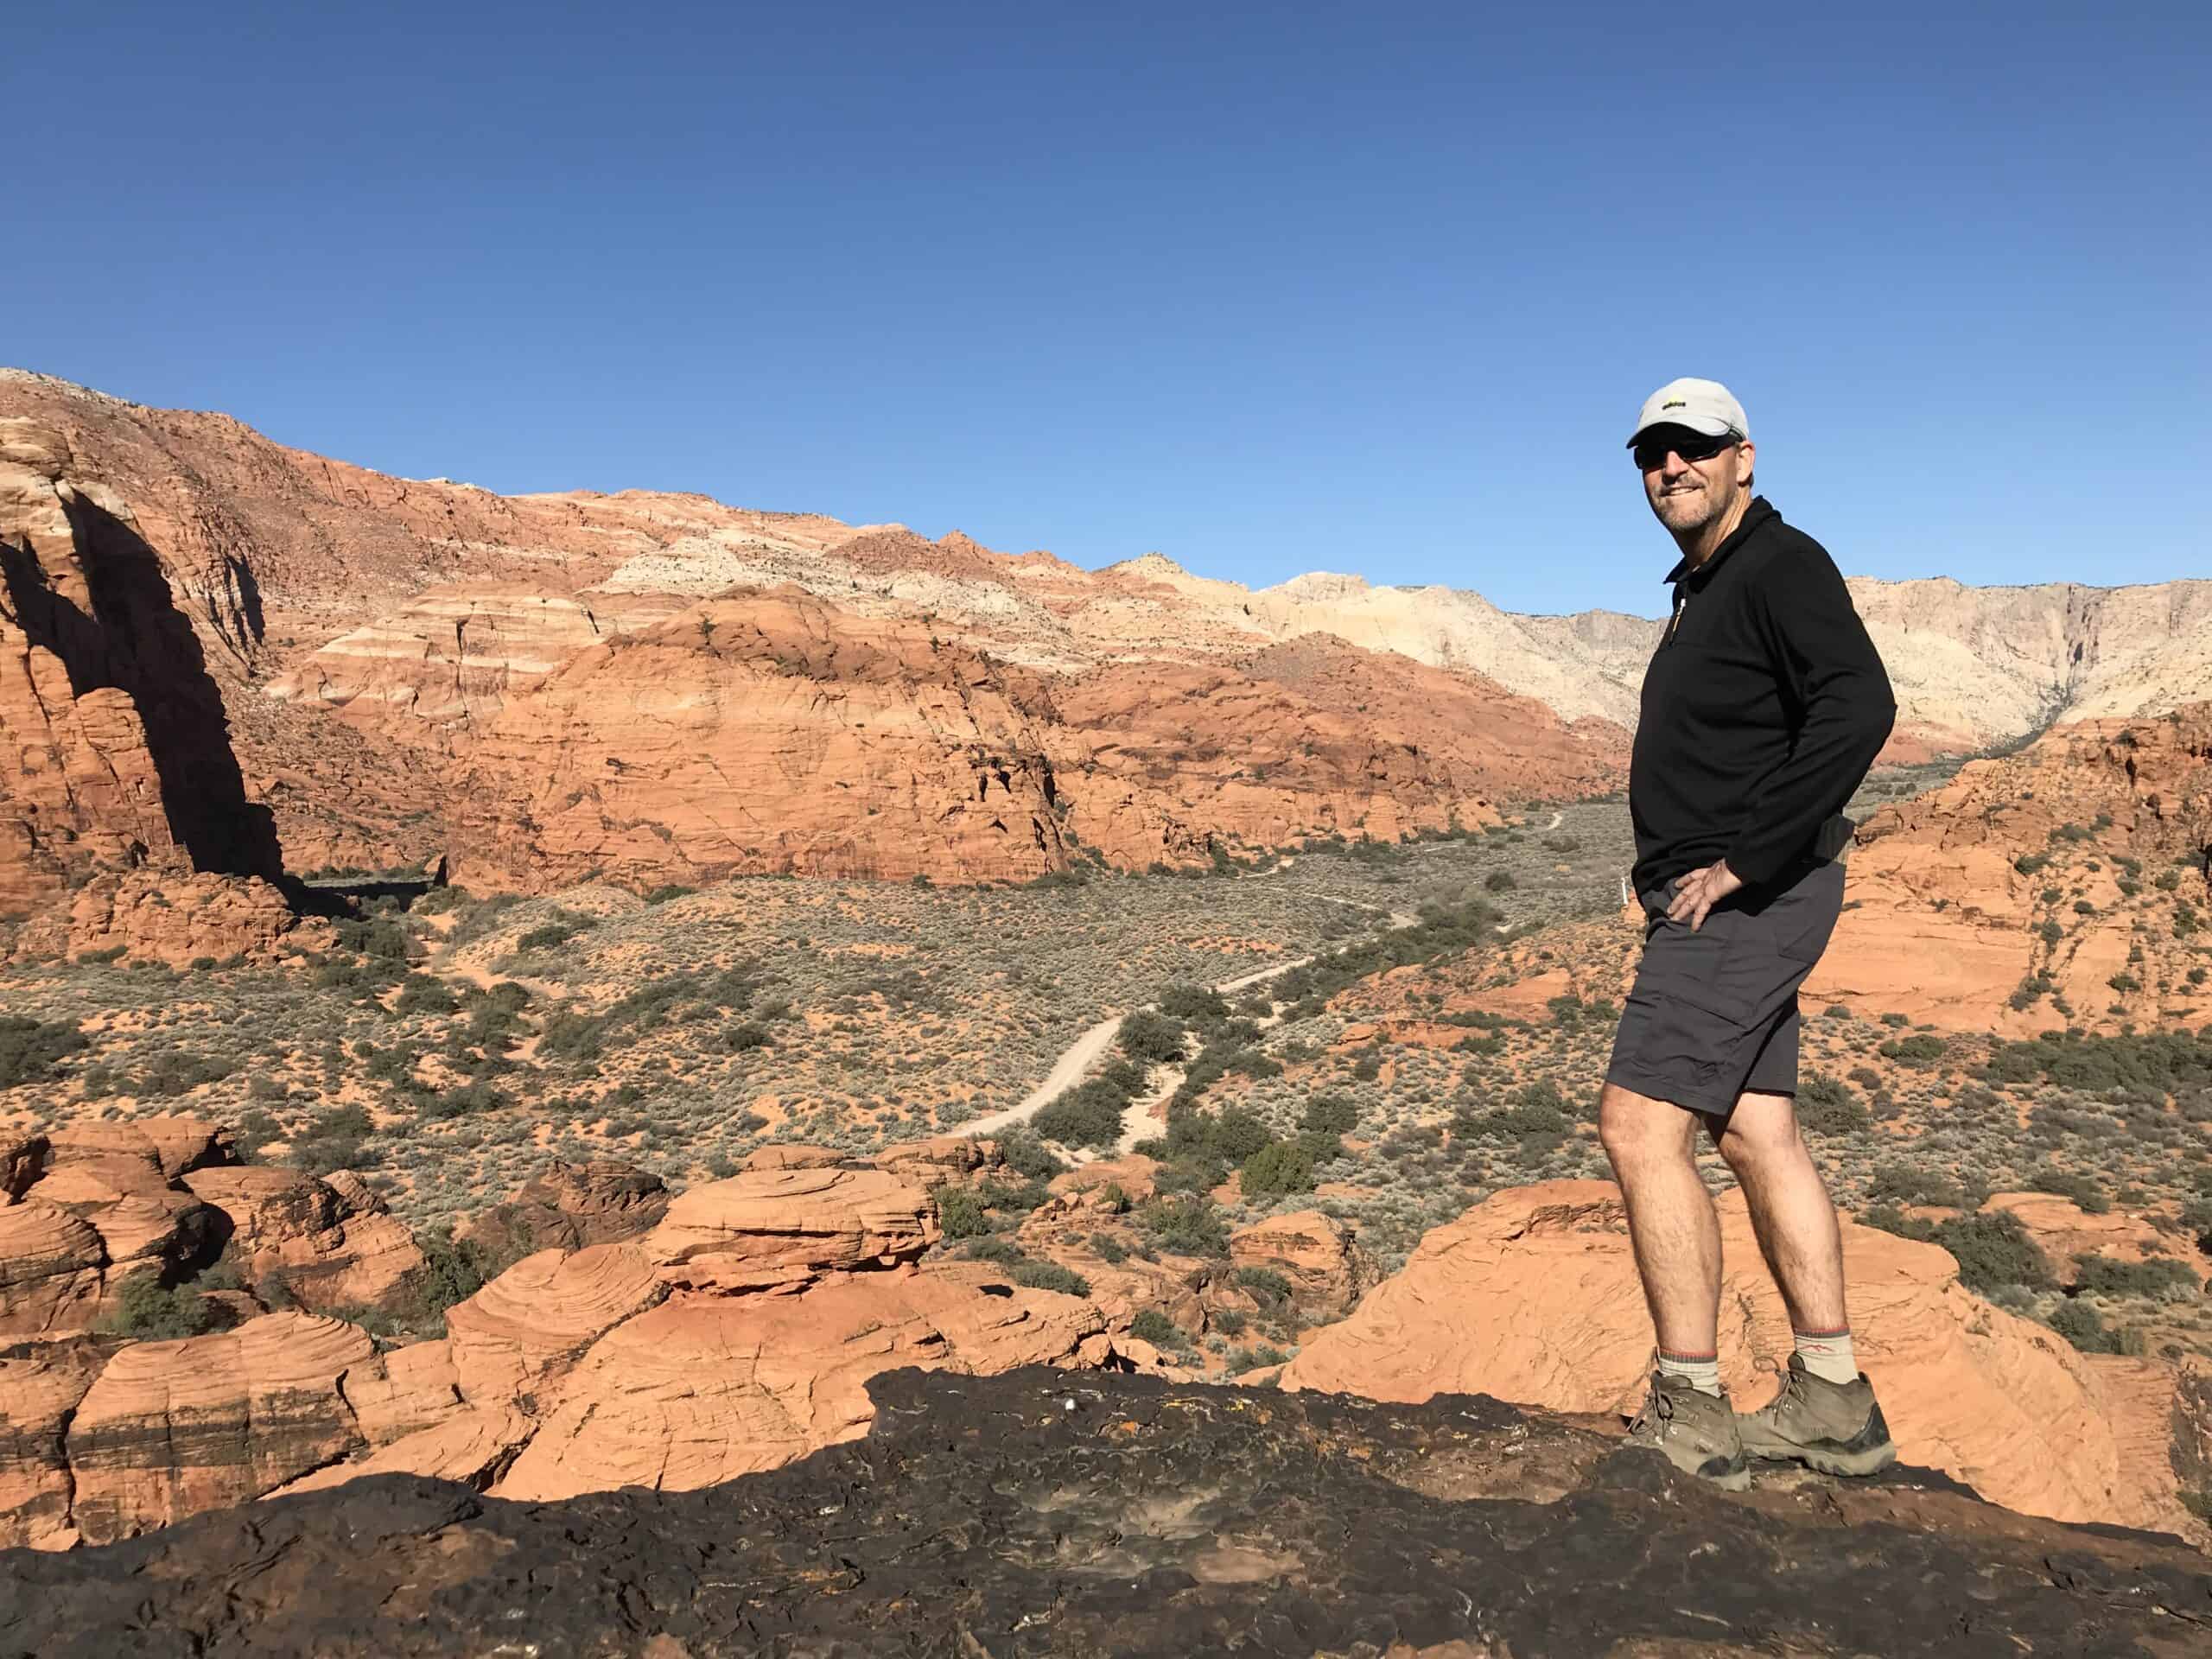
[[0, 370, 2212, 902]]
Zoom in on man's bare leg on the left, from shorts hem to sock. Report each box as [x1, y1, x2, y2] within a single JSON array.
[[1597, 1084, 1721, 1354]]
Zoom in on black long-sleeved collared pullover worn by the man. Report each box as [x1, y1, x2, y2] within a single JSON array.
[[1628, 495, 1897, 893]]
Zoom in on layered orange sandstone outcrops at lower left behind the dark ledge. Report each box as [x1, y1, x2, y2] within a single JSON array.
[[0, 1159, 1174, 1548]]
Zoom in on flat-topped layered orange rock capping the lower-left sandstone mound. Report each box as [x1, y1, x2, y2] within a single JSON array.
[[641, 1168, 940, 1292]]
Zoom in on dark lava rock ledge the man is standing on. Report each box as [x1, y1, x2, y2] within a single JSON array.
[[0, 1367, 2212, 1659]]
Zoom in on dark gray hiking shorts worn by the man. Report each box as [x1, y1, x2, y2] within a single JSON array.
[[1606, 858, 1842, 1117]]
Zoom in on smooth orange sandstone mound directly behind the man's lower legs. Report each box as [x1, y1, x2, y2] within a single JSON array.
[[1283, 1181, 2212, 1541]]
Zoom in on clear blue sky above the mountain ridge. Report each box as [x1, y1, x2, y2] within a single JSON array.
[[0, 3, 2212, 615]]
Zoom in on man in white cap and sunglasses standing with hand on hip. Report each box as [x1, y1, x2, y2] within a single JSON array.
[[1599, 380, 1896, 1491]]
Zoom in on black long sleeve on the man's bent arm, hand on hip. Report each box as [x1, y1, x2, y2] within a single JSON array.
[[1727, 537, 1897, 885]]
